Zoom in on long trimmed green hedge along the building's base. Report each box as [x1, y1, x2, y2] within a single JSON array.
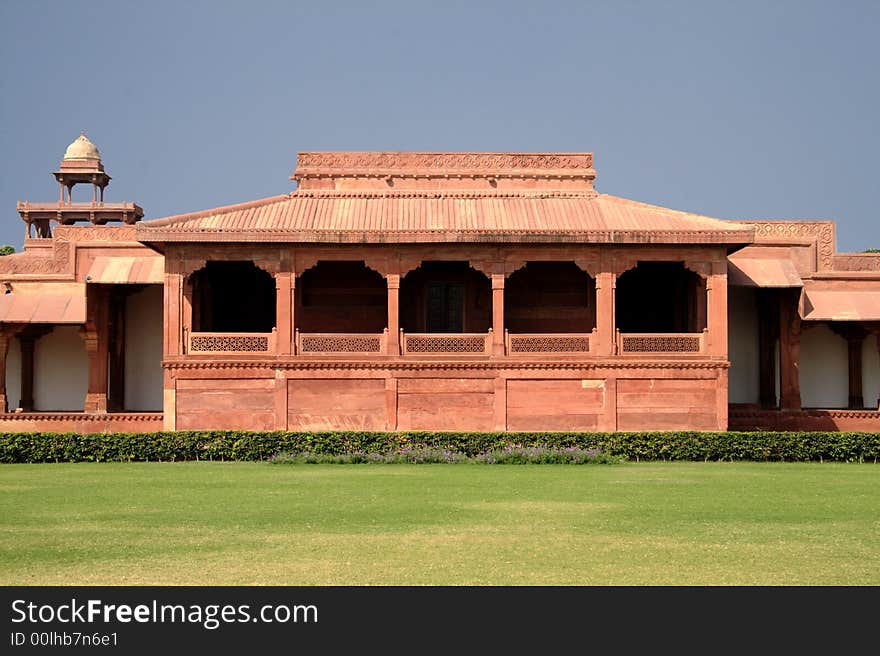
[[0, 431, 880, 463]]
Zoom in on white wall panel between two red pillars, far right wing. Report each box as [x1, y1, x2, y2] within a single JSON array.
[[800, 321, 849, 408]]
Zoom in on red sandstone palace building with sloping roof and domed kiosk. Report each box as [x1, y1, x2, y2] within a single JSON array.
[[0, 136, 880, 431]]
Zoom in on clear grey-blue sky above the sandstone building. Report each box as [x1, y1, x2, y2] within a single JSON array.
[[0, 0, 880, 250]]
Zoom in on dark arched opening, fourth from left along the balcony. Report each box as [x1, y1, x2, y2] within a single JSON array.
[[504, 262, 596, 333]]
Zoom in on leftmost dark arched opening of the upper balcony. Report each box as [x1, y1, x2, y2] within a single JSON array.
[[190, 261, 275, 333]]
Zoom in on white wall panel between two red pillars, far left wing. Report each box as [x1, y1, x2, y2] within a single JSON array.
[[34, 326, 89, 411]]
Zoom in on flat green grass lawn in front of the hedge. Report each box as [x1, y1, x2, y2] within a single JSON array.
[[0, 462, 880, 585]]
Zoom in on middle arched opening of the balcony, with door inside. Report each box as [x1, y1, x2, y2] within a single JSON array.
[[400, 261, 492, 333]]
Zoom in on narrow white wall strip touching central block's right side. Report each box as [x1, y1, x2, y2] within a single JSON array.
[[727, 286, 760, 403]]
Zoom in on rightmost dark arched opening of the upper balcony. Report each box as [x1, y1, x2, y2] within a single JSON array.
[[615, 262, 706, 333]]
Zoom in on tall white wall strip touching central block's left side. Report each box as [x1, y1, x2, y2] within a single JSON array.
[[125, 285, 163, 412]]
